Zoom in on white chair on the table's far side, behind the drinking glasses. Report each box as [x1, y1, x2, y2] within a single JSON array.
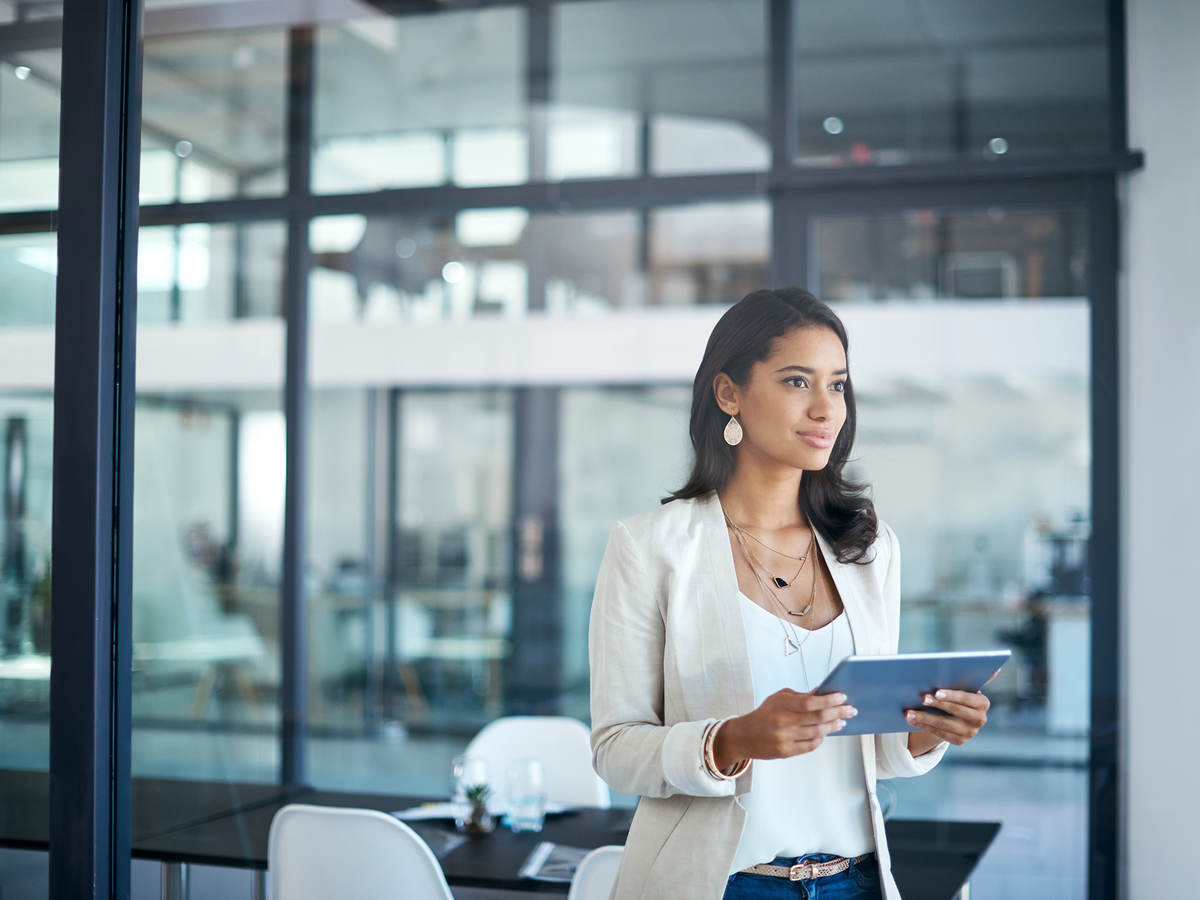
[[464, 715, 610, 809]]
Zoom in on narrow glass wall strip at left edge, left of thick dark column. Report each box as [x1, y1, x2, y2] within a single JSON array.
[[0, 2, 61, 898]]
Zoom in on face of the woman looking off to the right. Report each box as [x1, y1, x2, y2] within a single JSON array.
[[714, 325, 847, 469]]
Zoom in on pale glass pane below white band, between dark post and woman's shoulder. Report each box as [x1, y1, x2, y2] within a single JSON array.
[[558, 386, 691, 721]]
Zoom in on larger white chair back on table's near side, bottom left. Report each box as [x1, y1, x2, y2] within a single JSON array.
[[266, 803, 454, 900]]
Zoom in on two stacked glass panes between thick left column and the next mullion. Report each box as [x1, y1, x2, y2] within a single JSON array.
[[132, 15, 287, 781]]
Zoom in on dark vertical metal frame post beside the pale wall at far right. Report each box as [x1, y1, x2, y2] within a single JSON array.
[[1087, 176, 1121, 900]]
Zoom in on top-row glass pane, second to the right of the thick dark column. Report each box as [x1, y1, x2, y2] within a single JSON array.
[[313, 7, 529, 193]]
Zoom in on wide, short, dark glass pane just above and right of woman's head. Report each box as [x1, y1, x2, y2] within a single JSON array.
[[812, 208, 1087, 301]]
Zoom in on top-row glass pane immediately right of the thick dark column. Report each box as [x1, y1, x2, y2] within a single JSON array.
[[140, 31, 287, 203]]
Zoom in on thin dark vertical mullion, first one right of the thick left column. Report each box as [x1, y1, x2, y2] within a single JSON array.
[[280, 28, 314, 785]]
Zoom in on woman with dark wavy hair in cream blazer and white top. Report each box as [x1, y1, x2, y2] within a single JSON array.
[[589, 288, 989, 900]]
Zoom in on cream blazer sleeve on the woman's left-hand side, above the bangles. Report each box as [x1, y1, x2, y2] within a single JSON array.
[[588, 522, 734, 797]]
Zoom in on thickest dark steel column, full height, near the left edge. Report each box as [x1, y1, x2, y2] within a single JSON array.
[[49, 0, 142, 900]]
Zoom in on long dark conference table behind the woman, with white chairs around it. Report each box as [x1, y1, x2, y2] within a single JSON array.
[[0, 770, 1000, 900]]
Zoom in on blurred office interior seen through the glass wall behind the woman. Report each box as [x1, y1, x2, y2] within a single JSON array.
[[0, 0, 1180, 900]]
